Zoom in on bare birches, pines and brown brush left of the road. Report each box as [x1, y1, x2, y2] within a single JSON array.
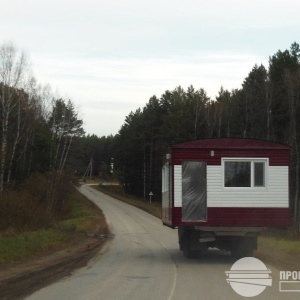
[[0, 43, 84, 230]]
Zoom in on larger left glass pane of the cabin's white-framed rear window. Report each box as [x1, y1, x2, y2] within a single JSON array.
[[225, 161, 251, 187]]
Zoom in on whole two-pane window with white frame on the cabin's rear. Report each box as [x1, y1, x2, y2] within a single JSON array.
[[223, 159, 267, 187]]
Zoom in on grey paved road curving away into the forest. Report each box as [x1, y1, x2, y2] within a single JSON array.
[[28, 185, 300, 300]]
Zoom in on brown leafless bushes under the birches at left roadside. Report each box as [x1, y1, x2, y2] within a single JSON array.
[[0, 174, 73, 234]]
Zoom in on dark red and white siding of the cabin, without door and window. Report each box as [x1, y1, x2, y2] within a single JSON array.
[[163, 139, 291, 227]]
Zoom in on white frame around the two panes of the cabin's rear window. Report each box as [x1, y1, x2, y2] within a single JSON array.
[[221, 157, 269, 190]]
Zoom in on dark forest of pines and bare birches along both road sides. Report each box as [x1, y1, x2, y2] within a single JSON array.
[[0, 42, 300, 232]]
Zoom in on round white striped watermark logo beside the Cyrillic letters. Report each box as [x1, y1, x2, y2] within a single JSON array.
[[225, 257, 272, 297]]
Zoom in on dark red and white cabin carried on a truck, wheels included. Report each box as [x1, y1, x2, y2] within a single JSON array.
[[162, 138, 291, 258]]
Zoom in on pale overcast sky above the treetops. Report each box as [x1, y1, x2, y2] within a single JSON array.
[[0, 0, 300, 136]]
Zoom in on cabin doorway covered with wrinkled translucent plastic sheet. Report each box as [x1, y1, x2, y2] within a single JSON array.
[[182, 161, 207, 222]]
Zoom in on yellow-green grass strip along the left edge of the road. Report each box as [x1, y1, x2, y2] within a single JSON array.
[[0, 188, 106, 264]]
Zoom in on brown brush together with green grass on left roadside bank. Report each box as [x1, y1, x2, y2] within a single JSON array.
[[0, 178, 107, 264]]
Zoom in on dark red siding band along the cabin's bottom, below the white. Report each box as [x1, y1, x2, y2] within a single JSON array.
[[173, 207, 292, 227]]
